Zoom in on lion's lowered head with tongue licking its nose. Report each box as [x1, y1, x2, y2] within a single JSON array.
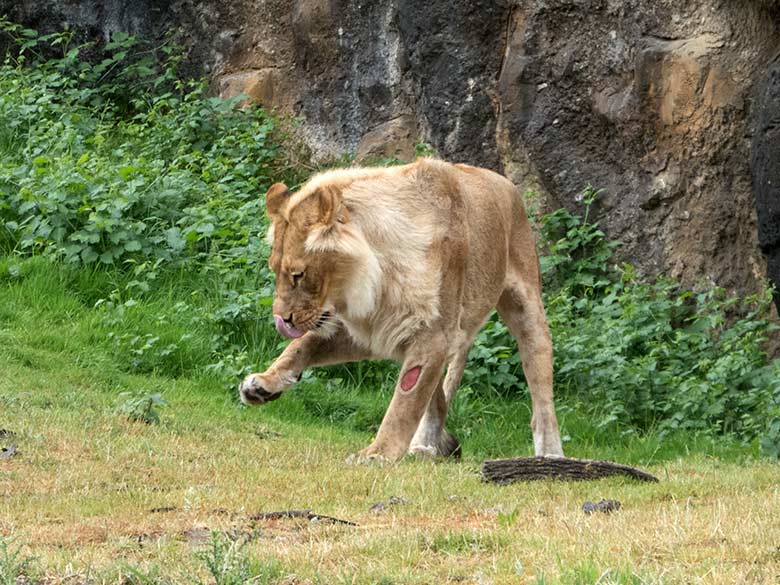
[[266, 183, 379, 338]]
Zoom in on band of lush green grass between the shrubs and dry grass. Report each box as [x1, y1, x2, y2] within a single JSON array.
[[0, 258, 757, 463]]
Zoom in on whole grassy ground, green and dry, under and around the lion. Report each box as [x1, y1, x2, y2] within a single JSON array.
[[0, 260, 780, 583]]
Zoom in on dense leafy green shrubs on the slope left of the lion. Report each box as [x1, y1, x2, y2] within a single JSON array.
[[0, 21, 290, 384]]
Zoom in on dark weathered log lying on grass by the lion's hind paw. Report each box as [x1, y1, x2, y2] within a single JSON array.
[[482, 457, 658, 484]]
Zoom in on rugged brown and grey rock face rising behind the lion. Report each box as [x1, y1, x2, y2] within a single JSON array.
[[0, 0, 780, 293]]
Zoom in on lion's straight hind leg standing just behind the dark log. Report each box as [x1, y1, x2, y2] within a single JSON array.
[[497, 279, 563, 457]]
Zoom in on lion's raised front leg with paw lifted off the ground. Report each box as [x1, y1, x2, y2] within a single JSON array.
[[238, 328, 370, 405]]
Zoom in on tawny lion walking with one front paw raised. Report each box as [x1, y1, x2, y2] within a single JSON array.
[[239, 159, 563, 461]]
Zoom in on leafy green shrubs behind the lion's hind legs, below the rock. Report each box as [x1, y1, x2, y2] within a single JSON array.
[[464, 189, 780, 457]]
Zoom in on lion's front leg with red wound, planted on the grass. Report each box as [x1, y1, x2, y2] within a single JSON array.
[[350, 335, 447, 461]]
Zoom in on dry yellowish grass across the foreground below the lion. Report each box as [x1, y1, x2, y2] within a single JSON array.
[[0, 360, 780, 583]]
